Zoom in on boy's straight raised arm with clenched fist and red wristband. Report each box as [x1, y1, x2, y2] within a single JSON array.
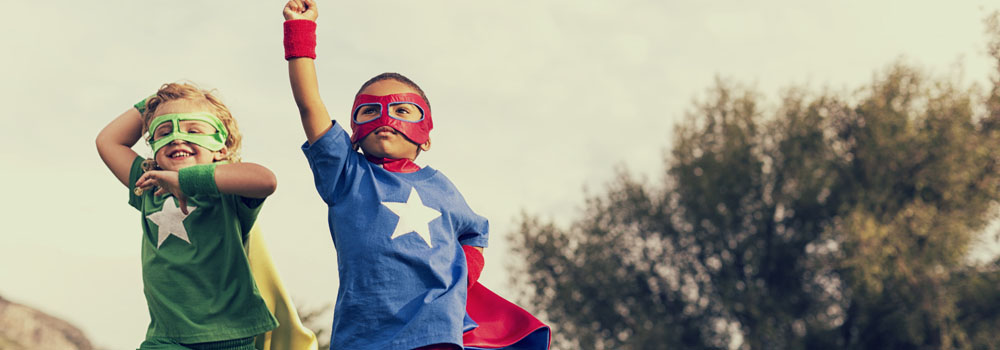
[[282, 0, 333, 144]]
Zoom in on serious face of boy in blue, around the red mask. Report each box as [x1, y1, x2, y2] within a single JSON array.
[[353, 79, 431, 160]]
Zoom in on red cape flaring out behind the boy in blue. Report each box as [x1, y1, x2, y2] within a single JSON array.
[[463, 283, 551, 349]]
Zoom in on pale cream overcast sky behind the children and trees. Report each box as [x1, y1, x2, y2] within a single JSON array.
[[0, 0, 1000, 349]]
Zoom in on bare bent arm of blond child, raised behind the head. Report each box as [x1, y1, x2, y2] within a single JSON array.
[[97, 108, 142, 187]]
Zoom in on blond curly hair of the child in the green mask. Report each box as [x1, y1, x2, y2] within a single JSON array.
[[142, 83, 243, 170]]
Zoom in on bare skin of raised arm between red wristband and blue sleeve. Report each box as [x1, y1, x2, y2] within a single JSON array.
[[288, 57, 333, 145]]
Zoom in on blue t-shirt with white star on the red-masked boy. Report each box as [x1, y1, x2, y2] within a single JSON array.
[[302, 123, 489, 350]]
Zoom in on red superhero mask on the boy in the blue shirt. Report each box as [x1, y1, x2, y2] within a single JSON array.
[[351, 93, 434, 145]]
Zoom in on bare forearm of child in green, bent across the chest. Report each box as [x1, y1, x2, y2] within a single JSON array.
[[215, 163, 278, 198]]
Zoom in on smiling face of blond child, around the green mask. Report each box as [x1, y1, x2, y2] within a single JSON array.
[[150, 99, 228, 171]]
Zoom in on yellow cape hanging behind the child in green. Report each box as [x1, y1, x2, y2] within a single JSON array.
[[246, 225, 319, 350]]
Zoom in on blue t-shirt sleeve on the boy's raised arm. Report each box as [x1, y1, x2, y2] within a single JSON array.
[[302, 121, 358, 205]]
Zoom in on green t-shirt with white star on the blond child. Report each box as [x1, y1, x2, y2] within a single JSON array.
[[129, 157, 278, 343]]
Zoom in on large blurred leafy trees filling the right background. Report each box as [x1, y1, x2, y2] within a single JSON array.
[[512, 11, 1000, 349]]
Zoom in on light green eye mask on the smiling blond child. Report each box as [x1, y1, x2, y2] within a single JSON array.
[[149, 112, 229, 154]]
